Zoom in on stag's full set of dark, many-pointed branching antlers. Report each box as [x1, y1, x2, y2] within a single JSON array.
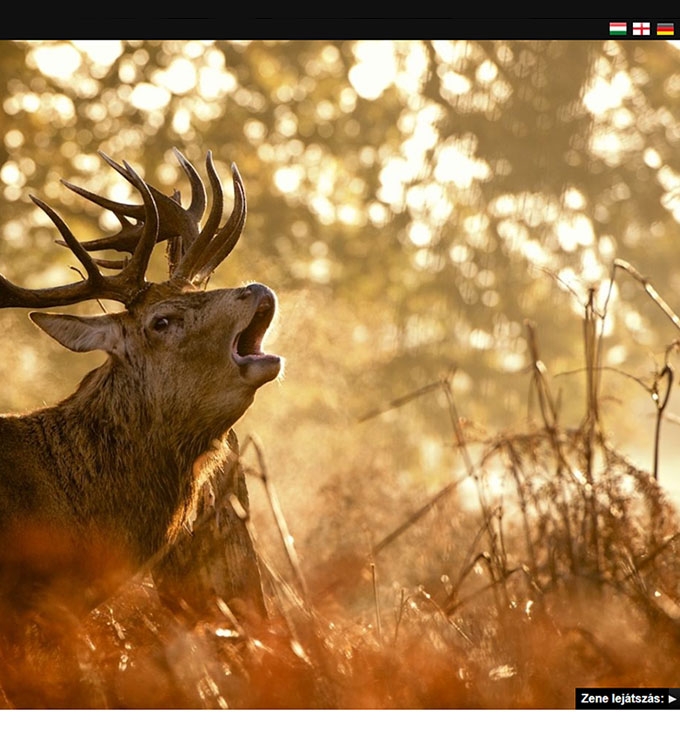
[[0, 150, 246, 308]]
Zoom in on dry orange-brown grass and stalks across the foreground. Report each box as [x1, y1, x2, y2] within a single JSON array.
[[1, 258, 680, 708]]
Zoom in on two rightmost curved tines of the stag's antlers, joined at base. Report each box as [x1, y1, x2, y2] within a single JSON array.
[[172, 153, 247, 284]]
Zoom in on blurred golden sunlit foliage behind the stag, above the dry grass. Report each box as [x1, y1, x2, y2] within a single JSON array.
[[0, 41, 680, 544]]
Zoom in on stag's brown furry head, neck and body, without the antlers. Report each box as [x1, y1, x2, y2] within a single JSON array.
[[0, 283, 280, 611]]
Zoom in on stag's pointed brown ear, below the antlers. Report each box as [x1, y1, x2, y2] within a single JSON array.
[[29, 312, 123, 355]]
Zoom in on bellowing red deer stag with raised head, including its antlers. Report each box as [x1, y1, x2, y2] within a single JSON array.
[[0, 152, 281, 632]]
